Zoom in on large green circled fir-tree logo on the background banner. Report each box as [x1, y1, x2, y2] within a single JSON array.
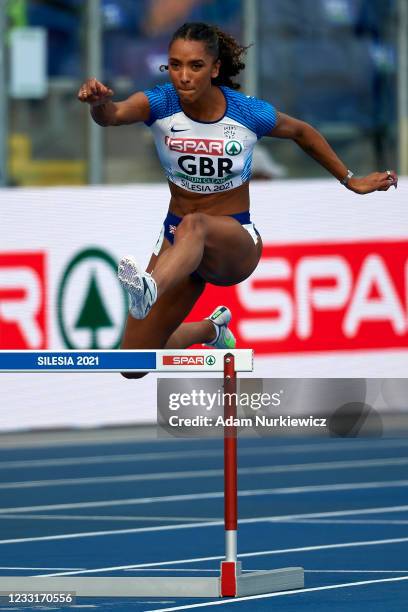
[[57, 248, 128, 349]]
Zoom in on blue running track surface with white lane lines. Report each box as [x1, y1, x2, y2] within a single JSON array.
[[0, 438, 408, 612]]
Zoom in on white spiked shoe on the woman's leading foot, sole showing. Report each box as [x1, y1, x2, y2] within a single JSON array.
[[118, 257, 157, 319]]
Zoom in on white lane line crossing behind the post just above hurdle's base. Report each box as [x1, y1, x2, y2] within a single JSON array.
[[39, 538, 408, 576]]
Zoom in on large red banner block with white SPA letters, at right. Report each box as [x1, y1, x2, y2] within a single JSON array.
[[188, 240, 408, 354]]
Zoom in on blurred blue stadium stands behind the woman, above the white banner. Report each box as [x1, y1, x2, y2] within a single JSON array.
[[1, 0, 398, 186]]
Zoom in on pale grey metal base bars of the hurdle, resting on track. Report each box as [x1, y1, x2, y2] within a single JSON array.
[[0, 567, 304, 598]]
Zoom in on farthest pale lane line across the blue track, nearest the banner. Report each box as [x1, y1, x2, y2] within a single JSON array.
[[0, 440, 407, 470]]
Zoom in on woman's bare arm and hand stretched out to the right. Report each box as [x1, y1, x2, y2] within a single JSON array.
[[266, 113, 398, 195]]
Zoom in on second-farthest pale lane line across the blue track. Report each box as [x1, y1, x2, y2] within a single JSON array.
[[0, 457, 408, 489]]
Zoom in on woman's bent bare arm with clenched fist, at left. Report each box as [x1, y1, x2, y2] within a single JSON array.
[[78, 78, 150, 126]]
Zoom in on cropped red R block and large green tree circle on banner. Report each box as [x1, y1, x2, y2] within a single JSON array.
[[0, 247, 127, 349]]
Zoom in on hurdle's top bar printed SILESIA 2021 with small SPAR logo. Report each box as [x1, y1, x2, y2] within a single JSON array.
[[0, 349, 253, 373]]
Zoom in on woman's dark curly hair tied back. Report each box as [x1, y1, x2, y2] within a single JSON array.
[[169, 22, 248, 89]]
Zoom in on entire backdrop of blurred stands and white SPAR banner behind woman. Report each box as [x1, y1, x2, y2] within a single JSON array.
[[0, 0, 408, 431]]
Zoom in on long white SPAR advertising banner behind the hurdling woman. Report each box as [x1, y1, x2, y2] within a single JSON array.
[[0, 179, 408, 431]]
